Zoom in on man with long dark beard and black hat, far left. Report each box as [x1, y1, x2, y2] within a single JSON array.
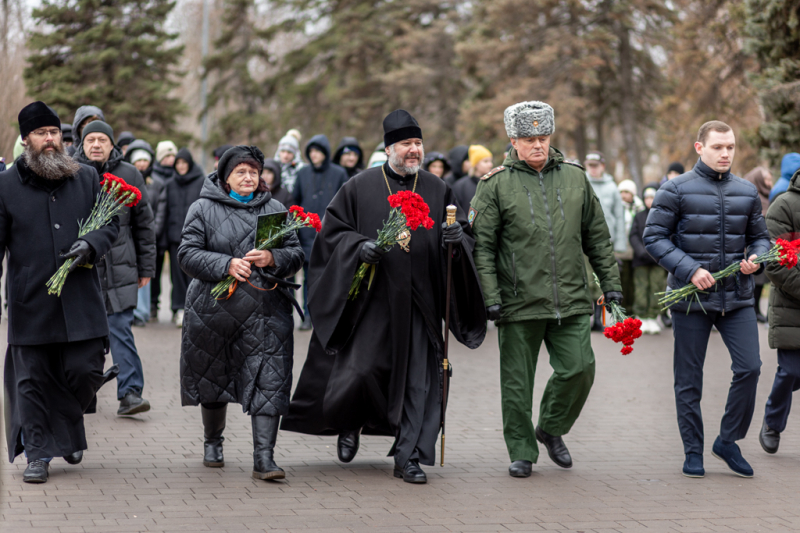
[[0, 102, 119, 483]]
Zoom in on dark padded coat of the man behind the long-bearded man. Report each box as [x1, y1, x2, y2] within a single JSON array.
[[75, 145, 156, 315]]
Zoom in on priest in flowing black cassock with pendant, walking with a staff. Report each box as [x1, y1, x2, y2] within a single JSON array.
[[282, 110, 486, 483]]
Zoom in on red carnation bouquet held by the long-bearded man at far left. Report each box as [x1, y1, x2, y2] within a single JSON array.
[[47, 172, 142, 296]]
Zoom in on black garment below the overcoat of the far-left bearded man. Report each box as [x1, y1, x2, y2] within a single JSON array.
[[4, 338, 108, 462]]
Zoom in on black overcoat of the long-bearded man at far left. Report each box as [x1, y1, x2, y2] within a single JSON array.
[[0, 158, 119, 345]]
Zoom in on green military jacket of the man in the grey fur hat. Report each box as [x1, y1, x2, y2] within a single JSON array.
[[469, 148, 622, 323]]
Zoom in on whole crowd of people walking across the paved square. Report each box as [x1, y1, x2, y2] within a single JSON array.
[[0, 96, 800, 490]]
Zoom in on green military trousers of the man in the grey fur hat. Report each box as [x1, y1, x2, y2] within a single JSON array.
[[498, 315, 594, 463]]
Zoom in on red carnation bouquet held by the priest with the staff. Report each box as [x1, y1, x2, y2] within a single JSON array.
[[349, 191, 433, 300]]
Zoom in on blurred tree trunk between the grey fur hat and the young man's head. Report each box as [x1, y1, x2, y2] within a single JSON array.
[[617, 23, 643, 188]]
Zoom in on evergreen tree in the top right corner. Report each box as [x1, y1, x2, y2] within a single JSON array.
[[745, 0, 800, 162]]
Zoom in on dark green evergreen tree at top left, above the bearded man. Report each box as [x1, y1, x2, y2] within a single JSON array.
[[25, 0, 185, 143]]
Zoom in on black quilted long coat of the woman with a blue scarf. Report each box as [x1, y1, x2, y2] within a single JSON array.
[[178, 173, 305, 416]]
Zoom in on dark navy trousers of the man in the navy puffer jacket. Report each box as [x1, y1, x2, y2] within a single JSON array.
[[672, 307, 761, 454]]
